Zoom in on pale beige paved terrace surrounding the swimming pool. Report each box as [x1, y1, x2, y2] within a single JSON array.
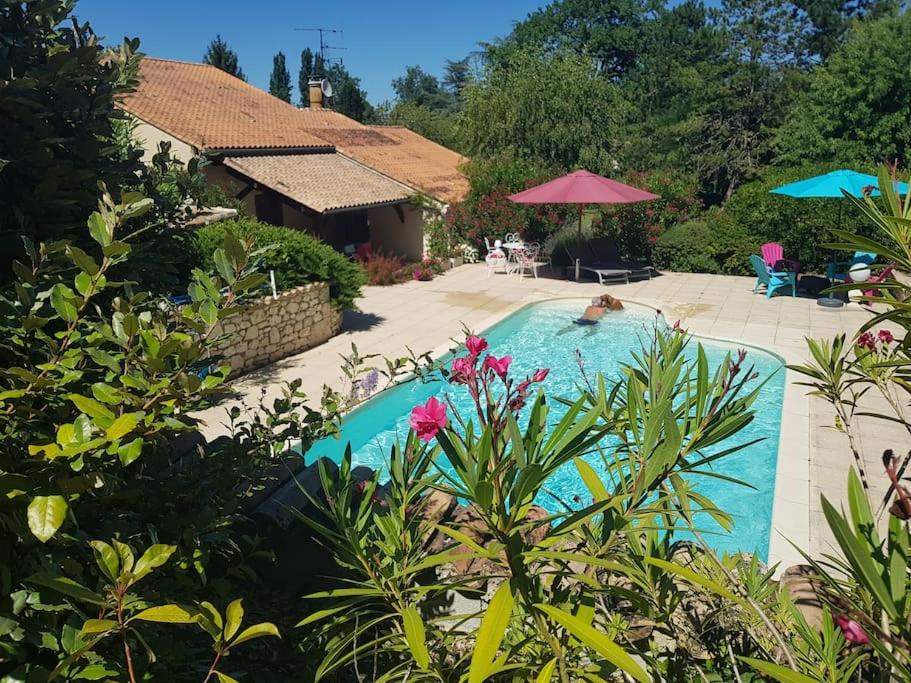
[[194, 264, 906, 567]]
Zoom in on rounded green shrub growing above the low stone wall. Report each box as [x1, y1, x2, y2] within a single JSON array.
[[194, 219, 366, 308]]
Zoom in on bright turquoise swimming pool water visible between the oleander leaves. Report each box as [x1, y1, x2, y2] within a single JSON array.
[[306, 300, 784, 559]]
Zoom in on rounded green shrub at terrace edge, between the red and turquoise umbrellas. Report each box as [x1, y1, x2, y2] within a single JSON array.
[[653, 214, 759, 275]]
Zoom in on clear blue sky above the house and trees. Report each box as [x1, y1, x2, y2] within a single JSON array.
[[76, 0, 545, 104]]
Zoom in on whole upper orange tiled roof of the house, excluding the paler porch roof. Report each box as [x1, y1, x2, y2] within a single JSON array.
[[122, 57, 468, 202]]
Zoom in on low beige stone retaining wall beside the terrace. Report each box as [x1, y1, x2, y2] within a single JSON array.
[[217, 282, 342, 375]]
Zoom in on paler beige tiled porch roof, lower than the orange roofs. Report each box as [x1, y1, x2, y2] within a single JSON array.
[[224, 154, 413, 213]]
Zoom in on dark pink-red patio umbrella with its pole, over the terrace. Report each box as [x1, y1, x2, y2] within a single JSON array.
[[509, 170, 659, 280]]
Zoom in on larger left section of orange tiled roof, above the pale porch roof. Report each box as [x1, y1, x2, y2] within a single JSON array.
[[121, 57, 332, 150]]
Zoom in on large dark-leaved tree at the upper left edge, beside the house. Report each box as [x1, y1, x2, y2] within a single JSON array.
[[0, 0, 139, 276]]
